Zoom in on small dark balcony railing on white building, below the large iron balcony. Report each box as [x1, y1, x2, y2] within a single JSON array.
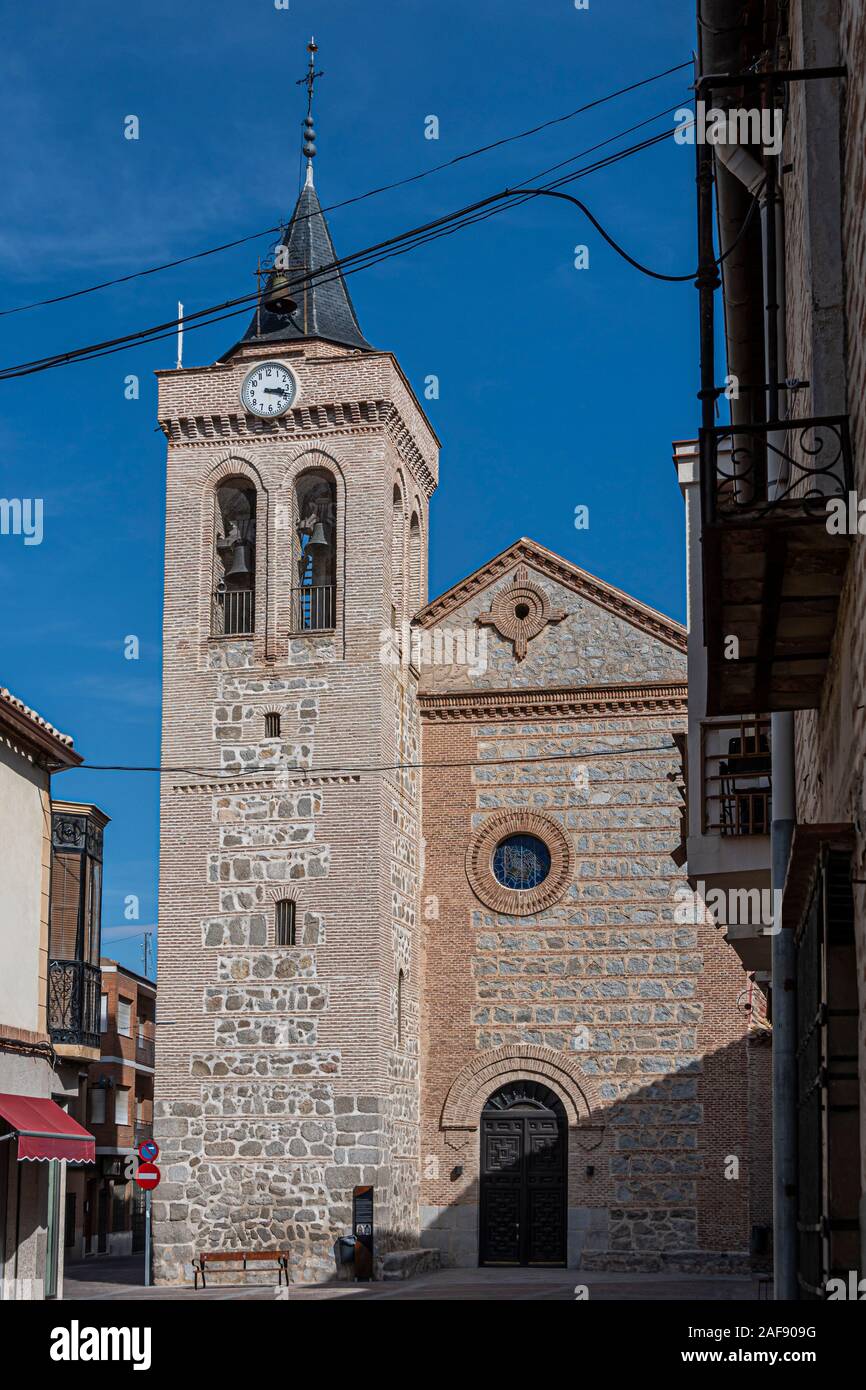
[[702, 719, 773, 835]]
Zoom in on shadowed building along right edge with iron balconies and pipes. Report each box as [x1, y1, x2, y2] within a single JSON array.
[[680, 0, 866, 1300]]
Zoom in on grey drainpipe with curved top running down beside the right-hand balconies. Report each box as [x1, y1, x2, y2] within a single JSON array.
[[716, 138, 799, 1301]]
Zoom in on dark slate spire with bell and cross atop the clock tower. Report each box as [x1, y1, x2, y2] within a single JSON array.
[[242, 39, 370, 349]]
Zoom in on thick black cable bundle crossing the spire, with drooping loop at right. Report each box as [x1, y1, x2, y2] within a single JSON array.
[[0, 117, 697, 381]]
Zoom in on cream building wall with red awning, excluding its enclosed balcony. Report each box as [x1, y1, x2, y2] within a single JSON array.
[[0, 689, 93, 1300]]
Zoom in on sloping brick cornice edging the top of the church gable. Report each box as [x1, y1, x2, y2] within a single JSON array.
[[413, 537, 688, 652]]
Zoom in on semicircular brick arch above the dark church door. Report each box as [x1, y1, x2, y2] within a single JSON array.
[[439, 1045, 601, 1130]]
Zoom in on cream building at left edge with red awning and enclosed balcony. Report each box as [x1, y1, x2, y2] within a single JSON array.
[[0, 688, 100, 1301]]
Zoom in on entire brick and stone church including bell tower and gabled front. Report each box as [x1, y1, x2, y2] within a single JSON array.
[[153, 81, 769, 1283]]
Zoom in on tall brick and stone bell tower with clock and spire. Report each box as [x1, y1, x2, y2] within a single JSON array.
[[153, 44, 438, 1282]]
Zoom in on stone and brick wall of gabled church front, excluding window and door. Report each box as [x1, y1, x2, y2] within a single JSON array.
[[421, 549, 766, 1269]]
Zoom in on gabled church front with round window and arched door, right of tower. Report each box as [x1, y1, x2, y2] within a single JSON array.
[[417, 541, 766, 1272]]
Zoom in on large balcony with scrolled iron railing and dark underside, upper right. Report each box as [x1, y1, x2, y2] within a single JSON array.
[[701, 416, 853, 714]]
